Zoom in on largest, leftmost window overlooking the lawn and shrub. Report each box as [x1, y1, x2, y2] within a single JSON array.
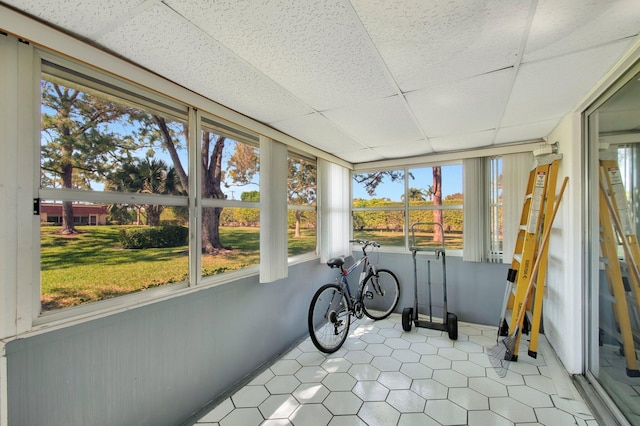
[[39, 61, 189, 311]]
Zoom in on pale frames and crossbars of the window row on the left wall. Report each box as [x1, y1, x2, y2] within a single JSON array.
[[28, 47, 320, 322]]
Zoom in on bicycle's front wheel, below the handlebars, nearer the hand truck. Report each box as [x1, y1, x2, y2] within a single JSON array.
[[362, 269, 400, 320]]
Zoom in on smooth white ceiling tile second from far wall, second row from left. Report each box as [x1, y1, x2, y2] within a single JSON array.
[[323, 96, 423, 146]]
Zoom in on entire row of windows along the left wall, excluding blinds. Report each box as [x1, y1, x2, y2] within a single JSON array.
[[34, 55, 298, 312]]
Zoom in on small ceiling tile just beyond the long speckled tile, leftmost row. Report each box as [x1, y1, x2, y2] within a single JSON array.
[[269, 113, 364, 154]]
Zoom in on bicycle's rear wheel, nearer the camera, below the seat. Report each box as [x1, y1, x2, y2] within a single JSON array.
[[309, 284, 351, 354]]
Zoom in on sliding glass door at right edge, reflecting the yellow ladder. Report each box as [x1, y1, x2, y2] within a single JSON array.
[[585, 64, 640, 425]]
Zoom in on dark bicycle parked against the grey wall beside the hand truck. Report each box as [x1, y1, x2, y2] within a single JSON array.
[[308, 240, 400, 353]]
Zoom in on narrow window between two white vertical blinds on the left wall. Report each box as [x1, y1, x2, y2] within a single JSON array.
[[287, 152, 317, 256]]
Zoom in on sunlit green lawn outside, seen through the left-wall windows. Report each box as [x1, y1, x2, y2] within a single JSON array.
[[41, 226, 316, 311]]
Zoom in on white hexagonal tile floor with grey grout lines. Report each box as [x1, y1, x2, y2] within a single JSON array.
[[196, 314, 597, 426]]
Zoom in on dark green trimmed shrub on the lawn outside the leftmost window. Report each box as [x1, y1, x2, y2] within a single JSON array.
[[118, 225, 189, 249]]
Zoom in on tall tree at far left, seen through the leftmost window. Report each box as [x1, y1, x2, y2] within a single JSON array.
[[41, 80, 136, 234]]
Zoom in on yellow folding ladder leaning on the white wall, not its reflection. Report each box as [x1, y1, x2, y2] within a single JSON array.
[[498, 154, 562, 361]]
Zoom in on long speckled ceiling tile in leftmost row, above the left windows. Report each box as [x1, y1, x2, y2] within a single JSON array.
[[98, 3, 311, 122]]
